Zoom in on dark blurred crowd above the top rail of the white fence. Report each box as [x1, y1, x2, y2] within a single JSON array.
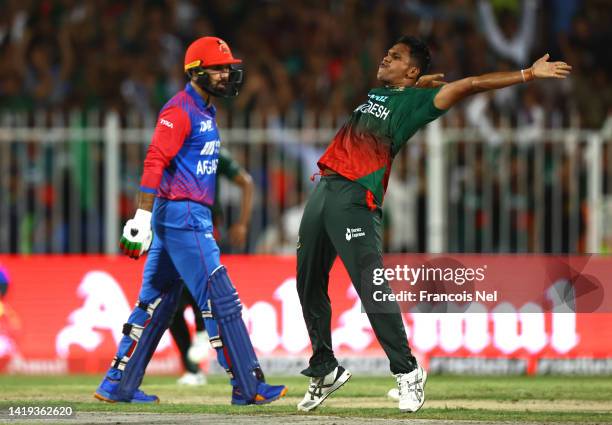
[[0, 0, 612, 128]]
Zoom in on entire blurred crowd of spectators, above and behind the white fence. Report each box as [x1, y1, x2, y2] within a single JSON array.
[[0, 0, 612, 253]]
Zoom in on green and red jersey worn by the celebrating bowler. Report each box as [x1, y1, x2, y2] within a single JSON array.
[[317, 87, 446, 203]]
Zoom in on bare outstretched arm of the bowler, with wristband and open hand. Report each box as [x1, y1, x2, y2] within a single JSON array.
[[434, 53, 572, 109]]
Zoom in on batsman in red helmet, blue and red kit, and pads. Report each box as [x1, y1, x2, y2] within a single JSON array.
[[94, 37, 287, 405]]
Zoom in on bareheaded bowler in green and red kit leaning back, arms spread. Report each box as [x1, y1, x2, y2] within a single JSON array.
[[297, 36, 571, 412]]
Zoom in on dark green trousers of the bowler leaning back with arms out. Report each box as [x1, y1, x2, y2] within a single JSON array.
[[297, 175, 416, 377]]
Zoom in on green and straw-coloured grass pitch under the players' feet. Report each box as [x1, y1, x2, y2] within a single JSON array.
[[0, 375, 612, 423]]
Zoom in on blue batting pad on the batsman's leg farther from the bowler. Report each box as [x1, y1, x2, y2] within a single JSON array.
[[108, 285, 180, 400]]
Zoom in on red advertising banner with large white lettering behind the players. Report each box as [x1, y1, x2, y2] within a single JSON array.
[[0, 255, 612, 373]]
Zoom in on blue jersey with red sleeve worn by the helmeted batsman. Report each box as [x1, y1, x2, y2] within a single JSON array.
[[140, 83, 221, 206]]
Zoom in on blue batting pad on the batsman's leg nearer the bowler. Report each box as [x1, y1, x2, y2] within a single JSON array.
[[204, 266, 264, 399]]
